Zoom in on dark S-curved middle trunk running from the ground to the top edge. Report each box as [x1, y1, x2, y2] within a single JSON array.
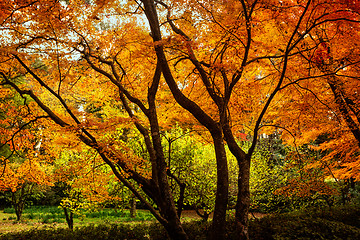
[[142, 0, 229, 239]]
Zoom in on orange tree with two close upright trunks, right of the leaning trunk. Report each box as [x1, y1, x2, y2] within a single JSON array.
[[142, 0, 357, 239]]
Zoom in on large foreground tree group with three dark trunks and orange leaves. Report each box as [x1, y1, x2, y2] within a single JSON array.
[[1, 0, 358, 239]]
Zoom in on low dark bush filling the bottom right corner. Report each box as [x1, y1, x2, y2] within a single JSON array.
[[249, 204, 360, 240]]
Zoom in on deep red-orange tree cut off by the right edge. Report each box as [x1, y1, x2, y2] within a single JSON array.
[[264, 1, 360, 195]]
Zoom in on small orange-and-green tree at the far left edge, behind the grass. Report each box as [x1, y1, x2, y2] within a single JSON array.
[[0, 86, 53, 221]]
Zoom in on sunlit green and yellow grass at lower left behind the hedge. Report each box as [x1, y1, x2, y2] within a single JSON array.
[[0, 206, 154, 234]]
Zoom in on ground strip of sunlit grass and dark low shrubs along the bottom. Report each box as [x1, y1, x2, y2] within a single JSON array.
[[0, 205, 360, 240]]
